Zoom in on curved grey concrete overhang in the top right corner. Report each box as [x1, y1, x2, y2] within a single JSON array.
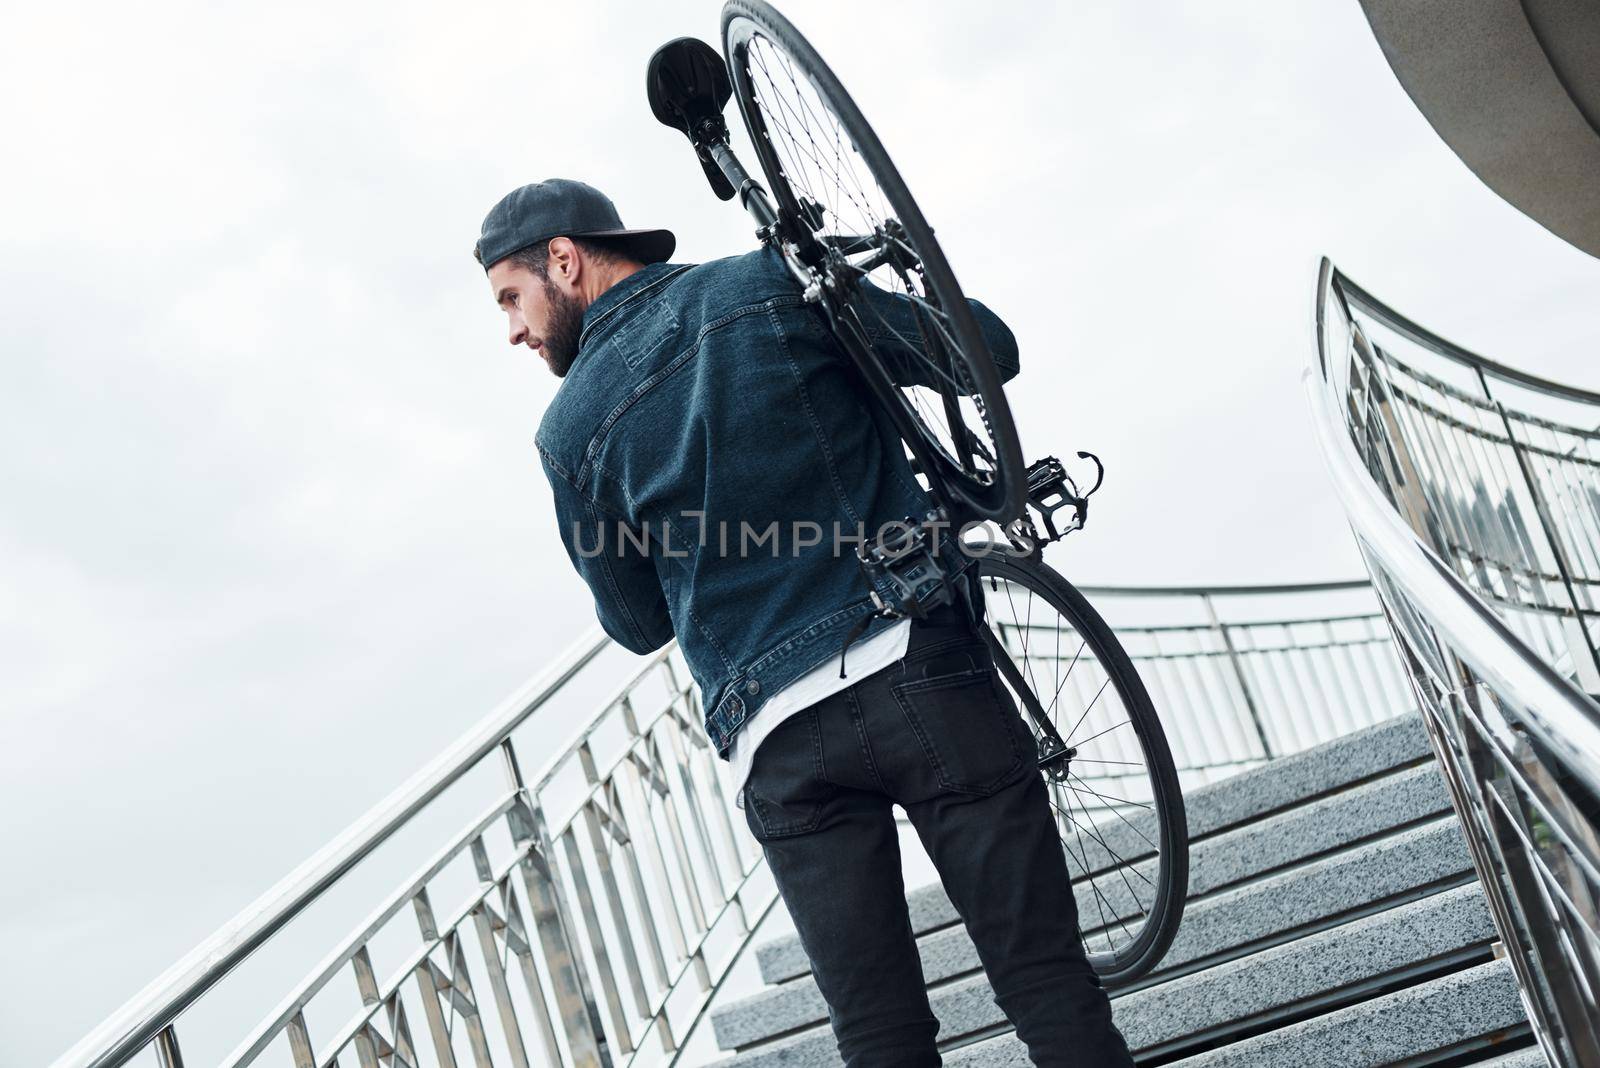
[[1362, 0, 1600, 256]]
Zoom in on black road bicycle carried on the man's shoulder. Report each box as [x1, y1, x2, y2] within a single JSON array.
[[646, 0, 1189, 985]]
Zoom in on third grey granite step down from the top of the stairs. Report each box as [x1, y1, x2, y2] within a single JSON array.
[[712, 819, 1470, 1048]]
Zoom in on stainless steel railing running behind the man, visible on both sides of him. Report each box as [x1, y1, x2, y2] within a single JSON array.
[[46, 582, 1411, 1068]]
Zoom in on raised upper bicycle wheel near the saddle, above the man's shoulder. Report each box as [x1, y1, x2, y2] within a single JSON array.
[[722, 0, 1026, 523]]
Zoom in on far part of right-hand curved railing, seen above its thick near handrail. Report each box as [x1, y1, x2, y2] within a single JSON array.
[[1325, 265, 1600, 694]]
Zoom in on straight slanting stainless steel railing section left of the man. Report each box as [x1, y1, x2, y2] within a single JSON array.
[[56, 632, 776, 1068]]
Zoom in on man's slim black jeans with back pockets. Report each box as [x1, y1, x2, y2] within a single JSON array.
[[744, 609, 1133, 1068]]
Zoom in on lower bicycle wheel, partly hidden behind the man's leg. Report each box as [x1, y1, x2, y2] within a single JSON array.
[[978, 553, 1189, 983]]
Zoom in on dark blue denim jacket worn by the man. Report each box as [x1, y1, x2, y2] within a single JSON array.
[[538, 248, 1018, 759]]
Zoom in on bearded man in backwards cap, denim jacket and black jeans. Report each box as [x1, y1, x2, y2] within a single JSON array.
[[474, 179, 1133, 1068]]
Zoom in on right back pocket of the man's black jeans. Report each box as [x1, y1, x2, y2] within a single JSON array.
[[890, 657, 1027, 796]]
